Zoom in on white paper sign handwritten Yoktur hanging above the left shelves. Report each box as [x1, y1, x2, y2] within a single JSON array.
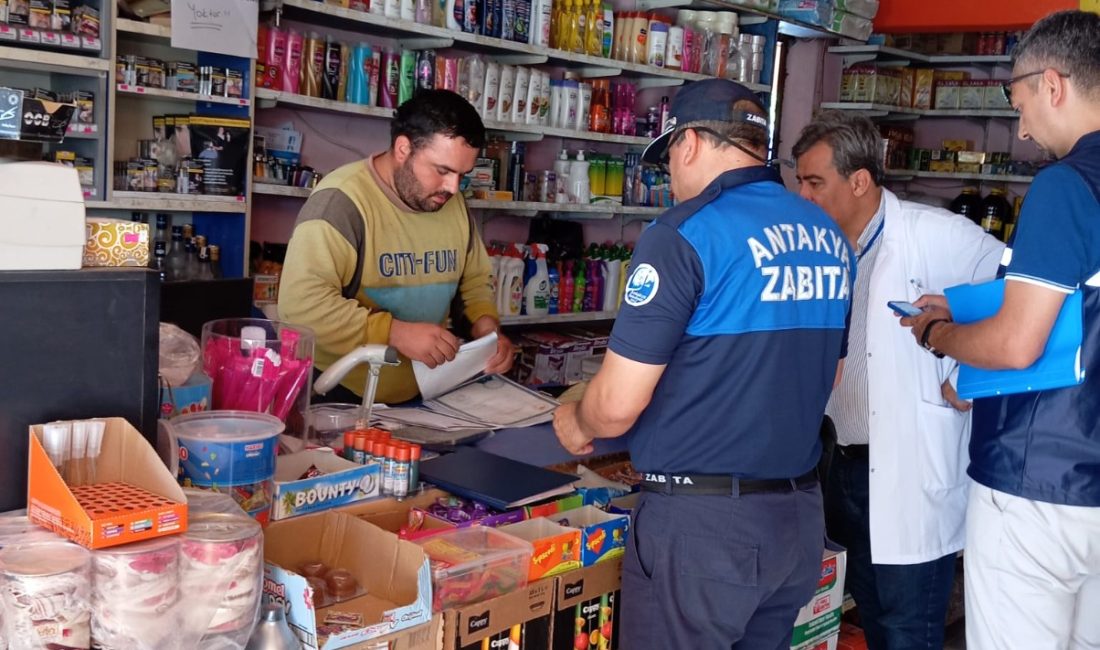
[[172, 0, 260, 58]]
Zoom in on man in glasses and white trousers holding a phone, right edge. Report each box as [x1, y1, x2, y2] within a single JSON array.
[[902, 11, 1100, 650]]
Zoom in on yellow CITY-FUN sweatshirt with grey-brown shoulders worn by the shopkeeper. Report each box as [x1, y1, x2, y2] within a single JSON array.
[[278, 159, 497, 404]]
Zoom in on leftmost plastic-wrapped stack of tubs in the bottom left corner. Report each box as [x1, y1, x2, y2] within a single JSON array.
[[0, 541, 91, 650]]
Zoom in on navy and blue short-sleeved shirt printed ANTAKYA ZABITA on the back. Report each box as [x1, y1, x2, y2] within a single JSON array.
[[611, 167, 855, 478]]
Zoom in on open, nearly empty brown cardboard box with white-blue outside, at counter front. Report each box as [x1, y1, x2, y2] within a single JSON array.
[[264, 513, 431, 650]]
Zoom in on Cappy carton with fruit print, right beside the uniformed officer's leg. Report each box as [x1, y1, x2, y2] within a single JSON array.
[[550, 560, 620, 650]]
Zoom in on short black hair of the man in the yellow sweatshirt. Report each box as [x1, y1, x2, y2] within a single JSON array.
[[389, 90, 485, 151]]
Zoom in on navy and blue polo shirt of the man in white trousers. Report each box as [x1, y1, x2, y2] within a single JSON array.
[[968, 131, 1100, 507]]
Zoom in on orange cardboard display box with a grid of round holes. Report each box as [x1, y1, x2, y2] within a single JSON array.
[[26, 418, 187, 549]]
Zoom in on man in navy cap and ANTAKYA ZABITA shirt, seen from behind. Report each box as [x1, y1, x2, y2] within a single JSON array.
[[554, 79, 855, 650]]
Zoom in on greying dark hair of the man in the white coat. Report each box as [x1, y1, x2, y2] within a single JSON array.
[[791, 111, 887, 185]]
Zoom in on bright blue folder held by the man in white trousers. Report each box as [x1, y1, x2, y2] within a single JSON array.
[[944, 279, 1085, 399]]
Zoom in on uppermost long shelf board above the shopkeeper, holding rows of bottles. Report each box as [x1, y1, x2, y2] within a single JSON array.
[[283, 0, 771, 92]]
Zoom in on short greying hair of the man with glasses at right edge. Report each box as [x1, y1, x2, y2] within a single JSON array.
[[1012, 10, 1100, 99]]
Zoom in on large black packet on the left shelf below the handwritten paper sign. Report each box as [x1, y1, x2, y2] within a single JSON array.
[[189, 115, 251, 196]]
